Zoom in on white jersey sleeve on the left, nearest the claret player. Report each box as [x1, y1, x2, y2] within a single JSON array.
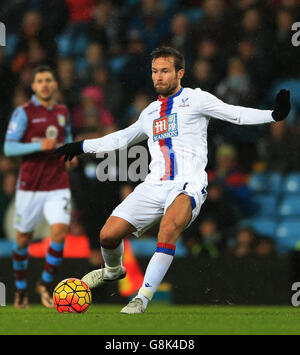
[[82, 118, 147, 153]]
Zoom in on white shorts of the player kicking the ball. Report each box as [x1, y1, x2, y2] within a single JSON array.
[[111, 181, 207, 237]]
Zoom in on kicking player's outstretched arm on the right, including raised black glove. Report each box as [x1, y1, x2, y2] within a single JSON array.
[[200, 89, 290, 125]]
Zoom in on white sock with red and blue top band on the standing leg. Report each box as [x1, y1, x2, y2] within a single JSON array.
[[136, 243, 176, 309]]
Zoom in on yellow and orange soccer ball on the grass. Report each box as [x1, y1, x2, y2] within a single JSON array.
[[53, 278, 92, 313]]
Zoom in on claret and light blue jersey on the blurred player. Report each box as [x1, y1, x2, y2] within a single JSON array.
[[4, 95, 72, 191]]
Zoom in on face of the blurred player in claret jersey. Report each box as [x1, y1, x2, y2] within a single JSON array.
[[32, 72, 57, 101]]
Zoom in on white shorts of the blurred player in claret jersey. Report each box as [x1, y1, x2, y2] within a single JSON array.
[[14, 189, 71, 233]]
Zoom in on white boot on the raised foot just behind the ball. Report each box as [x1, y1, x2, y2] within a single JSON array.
[[81, 266, 126, 289]]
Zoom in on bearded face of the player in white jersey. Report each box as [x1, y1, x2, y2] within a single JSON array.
[[152, 57, 183, 97]]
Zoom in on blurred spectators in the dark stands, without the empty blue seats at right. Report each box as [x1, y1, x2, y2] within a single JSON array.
[[0, 0, 300, 257]]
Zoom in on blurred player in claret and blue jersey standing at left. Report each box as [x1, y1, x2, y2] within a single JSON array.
[[4, 66, 72, 308]]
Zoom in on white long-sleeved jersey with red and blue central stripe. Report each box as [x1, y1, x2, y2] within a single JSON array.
[[83, 88, 274, 188]]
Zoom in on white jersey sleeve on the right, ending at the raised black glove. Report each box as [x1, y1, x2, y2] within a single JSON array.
[[196, 89, 275, 125]]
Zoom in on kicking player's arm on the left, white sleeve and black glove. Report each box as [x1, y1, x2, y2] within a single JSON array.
[[54, 120, 147, 161]]
